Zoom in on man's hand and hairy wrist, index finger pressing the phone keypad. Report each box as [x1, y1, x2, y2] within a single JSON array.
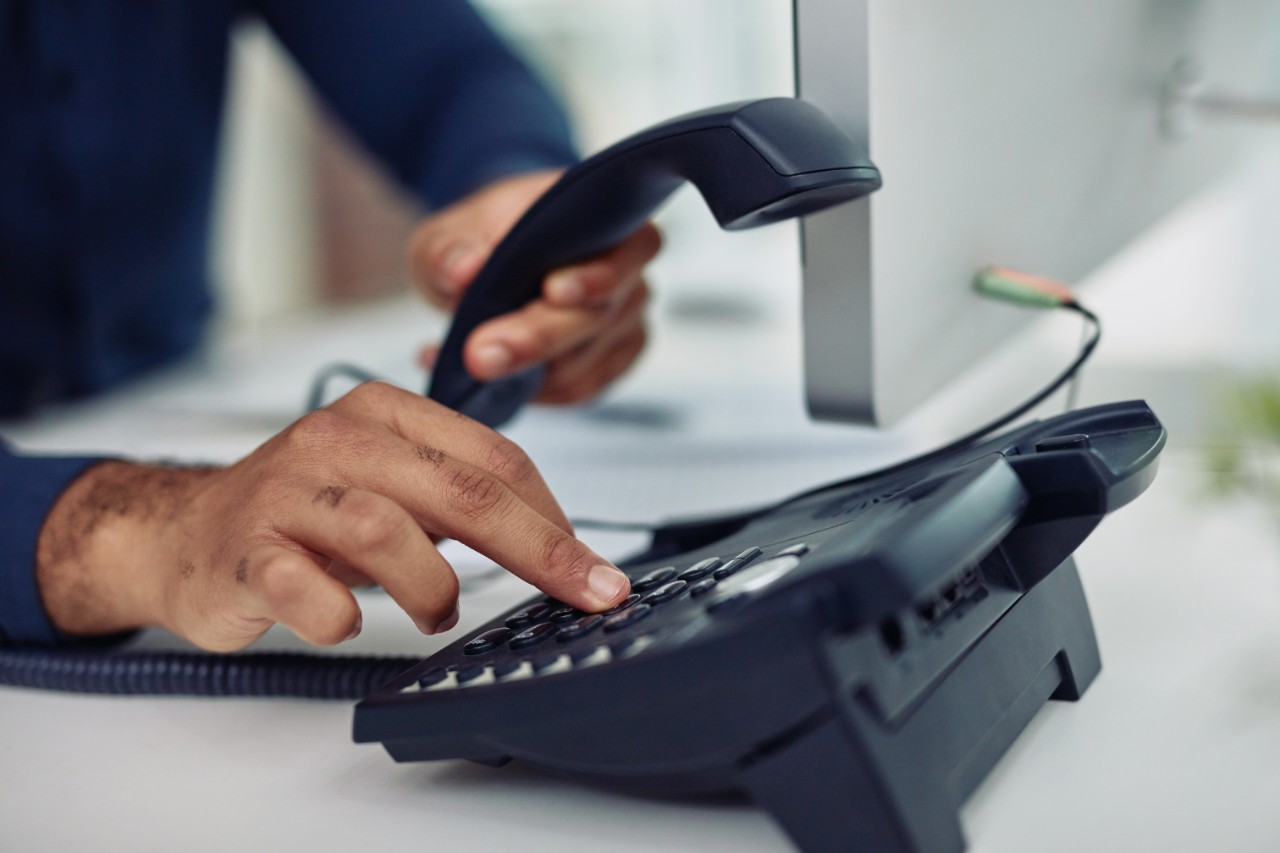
[[37, 383, 628, 651]]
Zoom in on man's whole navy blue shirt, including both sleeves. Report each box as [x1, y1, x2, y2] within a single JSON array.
[[0, 0, 573, 642]]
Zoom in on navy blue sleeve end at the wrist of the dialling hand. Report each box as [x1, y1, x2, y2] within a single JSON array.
[[0, 442, 101, 646]]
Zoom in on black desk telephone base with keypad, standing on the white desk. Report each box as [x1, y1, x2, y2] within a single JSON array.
[[355, 402, 1165, 852]]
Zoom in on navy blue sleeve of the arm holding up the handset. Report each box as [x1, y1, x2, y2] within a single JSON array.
[[253, 0, 576, 207]]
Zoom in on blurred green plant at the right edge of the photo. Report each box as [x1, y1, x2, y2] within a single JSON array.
[[1208, 374, 1280, 508]]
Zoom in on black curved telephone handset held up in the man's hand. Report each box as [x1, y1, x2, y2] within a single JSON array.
[[428, 97, 881, 427]]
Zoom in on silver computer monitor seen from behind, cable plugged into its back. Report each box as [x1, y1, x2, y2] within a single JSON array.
[[794, 0, 1280, 424]]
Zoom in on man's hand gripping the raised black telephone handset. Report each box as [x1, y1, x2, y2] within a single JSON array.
[[410, 172, 662, 403]]
